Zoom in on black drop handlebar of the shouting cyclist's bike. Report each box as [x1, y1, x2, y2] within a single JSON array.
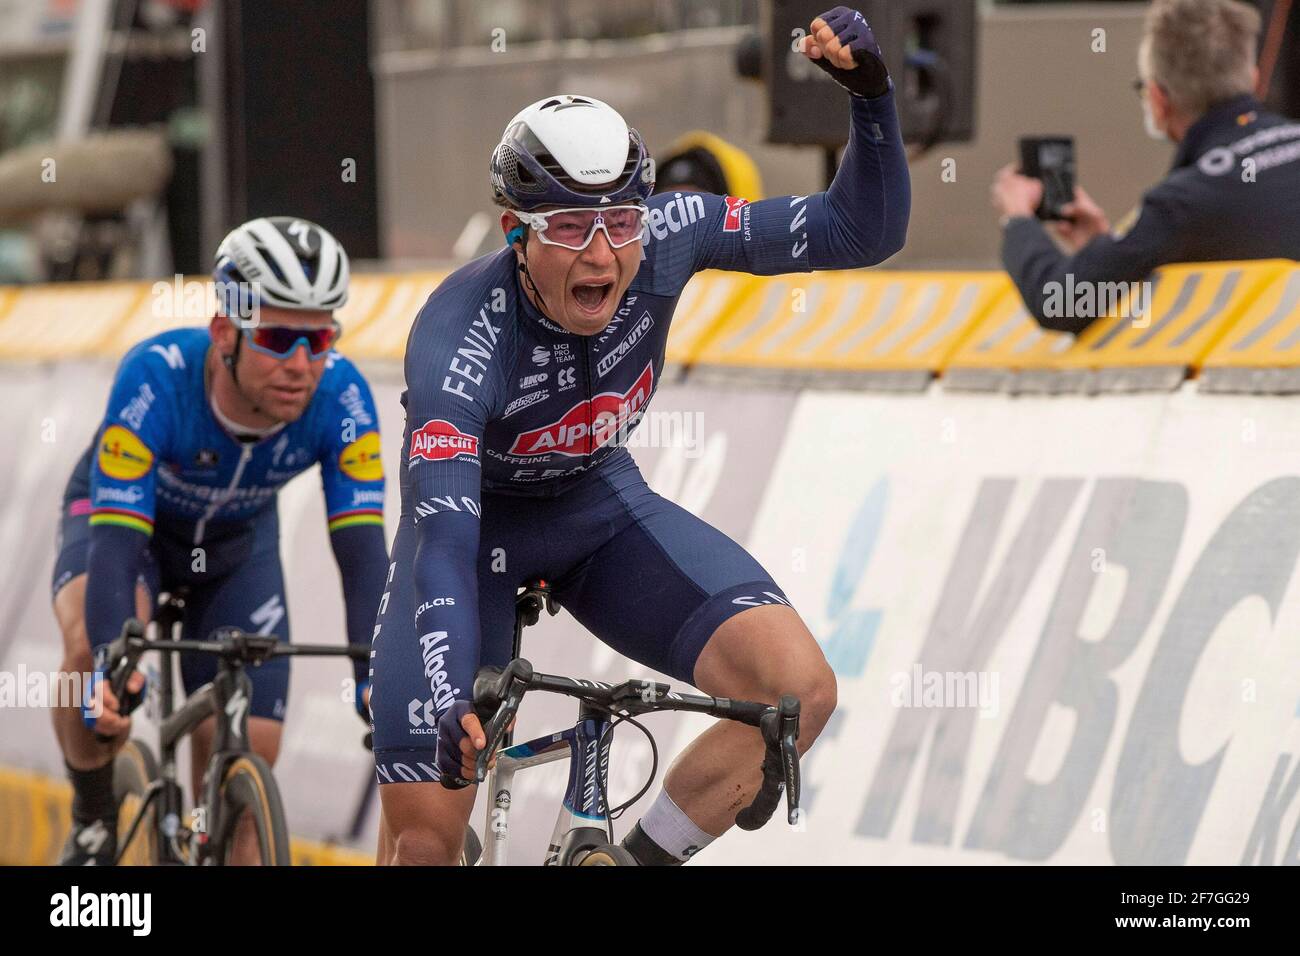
[[462, 657, 800, 830]]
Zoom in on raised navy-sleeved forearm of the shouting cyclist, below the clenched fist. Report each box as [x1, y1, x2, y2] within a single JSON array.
[[809, 92, 911, 269]]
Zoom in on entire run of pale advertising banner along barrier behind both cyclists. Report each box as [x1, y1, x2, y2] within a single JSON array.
[[0, 365, 1300, 865]]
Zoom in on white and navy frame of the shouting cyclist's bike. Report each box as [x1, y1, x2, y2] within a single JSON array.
[[480, 706, 614, 866]]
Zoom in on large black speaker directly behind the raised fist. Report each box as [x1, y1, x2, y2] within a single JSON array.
[[759, 0, 978, 147]]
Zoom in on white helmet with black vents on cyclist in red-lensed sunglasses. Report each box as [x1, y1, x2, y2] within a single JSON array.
[[212, 216, 348, 312]]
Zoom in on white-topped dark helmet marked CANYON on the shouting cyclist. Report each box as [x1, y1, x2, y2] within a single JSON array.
[[490, 94, 654, 212]]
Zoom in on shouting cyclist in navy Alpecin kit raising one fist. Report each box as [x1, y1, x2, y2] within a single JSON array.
[[371, 7, 910, 864]]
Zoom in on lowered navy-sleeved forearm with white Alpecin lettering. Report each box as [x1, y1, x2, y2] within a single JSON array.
[[412, 512, 483, 713]]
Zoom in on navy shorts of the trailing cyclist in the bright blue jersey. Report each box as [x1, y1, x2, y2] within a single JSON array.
[[51, 451, 289, 721]]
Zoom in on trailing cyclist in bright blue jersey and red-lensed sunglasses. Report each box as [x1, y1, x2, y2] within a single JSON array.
[[53, 217, 387, 865]]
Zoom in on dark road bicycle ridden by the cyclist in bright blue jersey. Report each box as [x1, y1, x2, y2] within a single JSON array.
[[97, 588, 371, 866]]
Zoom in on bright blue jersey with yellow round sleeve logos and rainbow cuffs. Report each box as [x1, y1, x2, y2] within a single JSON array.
[[90, 329, 384, 544]]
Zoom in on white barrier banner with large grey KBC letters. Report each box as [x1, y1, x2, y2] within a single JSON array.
[[701, 389, 1300, 864]]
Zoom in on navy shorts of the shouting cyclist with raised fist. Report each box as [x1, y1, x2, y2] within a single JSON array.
[[371, 453, 785, 783]]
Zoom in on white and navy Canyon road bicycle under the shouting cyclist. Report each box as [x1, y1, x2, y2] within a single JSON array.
[[462, 581, 800, 866]]
